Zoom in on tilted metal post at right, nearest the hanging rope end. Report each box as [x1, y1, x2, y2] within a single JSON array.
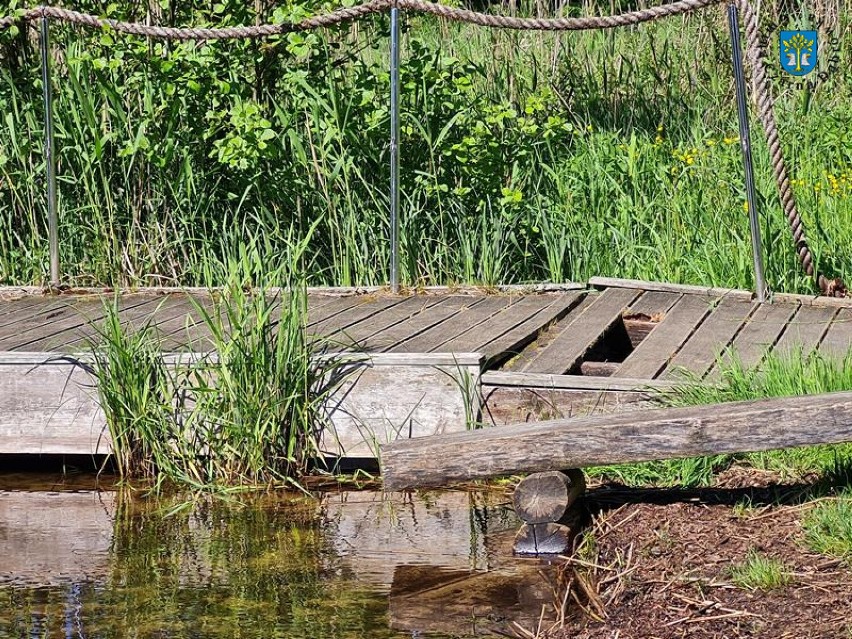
[[728, 4, 767, 302]]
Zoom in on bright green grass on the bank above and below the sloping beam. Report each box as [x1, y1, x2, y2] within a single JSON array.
[[587, 351, 852, 487]]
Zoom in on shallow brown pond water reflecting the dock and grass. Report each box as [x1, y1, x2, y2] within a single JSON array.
[[0, 474, 564, 639]]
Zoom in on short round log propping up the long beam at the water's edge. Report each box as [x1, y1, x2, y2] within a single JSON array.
[[512, 469, 586, 524]]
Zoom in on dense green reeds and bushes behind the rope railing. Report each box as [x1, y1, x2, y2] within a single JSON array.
[[0, 0, 852, 291]]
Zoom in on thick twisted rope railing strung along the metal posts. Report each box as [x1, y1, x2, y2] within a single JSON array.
[[0, 0, 846, 297]]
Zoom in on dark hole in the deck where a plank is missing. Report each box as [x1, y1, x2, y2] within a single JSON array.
[[569, 313, 663, 377]]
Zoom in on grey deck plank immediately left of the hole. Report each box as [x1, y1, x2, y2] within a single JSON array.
[[524, 288, 641, 375]]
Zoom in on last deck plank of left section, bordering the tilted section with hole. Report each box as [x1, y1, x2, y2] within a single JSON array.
[[443, 292, 584, 360]]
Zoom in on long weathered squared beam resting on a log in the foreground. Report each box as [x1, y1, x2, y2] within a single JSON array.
[[381, 392, 852, 490]]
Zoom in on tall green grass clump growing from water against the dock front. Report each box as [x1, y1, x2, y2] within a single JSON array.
[[85, 242, 342, 488]]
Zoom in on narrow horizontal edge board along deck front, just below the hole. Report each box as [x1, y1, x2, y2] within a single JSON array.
[[480, 371, 678, 393]]
